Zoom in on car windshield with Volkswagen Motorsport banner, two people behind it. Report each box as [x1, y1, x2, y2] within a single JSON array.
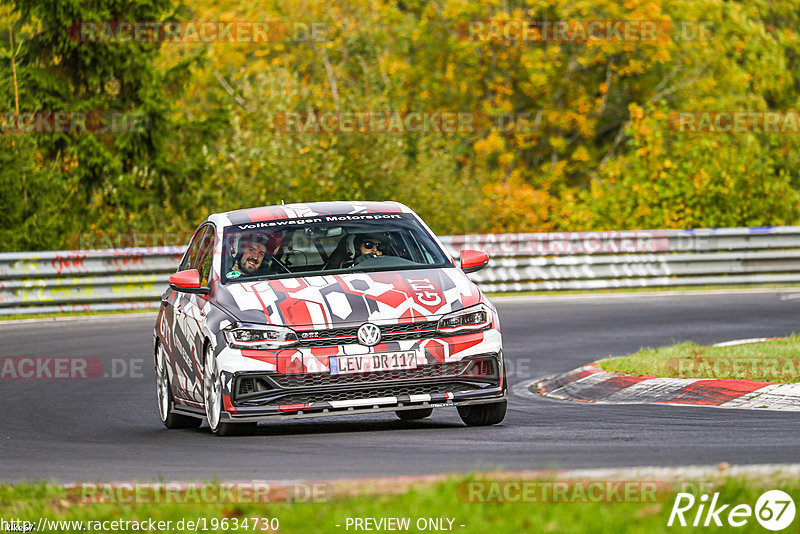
[[221, 213, 452, 283]]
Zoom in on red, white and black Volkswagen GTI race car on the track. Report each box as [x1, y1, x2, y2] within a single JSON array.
[[154, 202, 507, 435]]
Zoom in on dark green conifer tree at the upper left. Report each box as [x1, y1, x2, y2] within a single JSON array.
[[0, 0, 224, 249]]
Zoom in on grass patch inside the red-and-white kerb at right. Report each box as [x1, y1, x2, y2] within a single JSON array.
[[600, 335, 800, 382]]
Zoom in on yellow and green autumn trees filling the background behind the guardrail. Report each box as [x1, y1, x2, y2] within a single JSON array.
[[0, 0, 800, 250]]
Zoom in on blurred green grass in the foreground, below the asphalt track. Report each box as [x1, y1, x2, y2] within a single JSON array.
[[0, 477, 800, 534]]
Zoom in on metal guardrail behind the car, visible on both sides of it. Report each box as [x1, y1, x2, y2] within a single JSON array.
[[0, 226, 800, 315]]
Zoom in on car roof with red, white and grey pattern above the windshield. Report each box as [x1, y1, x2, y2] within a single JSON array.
[[208, 200, 413, 226]]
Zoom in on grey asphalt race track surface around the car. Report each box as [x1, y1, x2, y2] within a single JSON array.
[[0, 290, 800, 482]]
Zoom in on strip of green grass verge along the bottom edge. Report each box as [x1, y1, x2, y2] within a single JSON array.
[[0, 475, 800, 534]]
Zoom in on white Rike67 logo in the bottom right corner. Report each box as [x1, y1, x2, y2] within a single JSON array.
[[667, 490, 795, 531]]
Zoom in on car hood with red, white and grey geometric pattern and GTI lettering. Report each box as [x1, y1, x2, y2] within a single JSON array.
[[213, 267, 481, 330]]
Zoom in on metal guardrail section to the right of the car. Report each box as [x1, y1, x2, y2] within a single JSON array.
[[444, 226, 800, 292]]
